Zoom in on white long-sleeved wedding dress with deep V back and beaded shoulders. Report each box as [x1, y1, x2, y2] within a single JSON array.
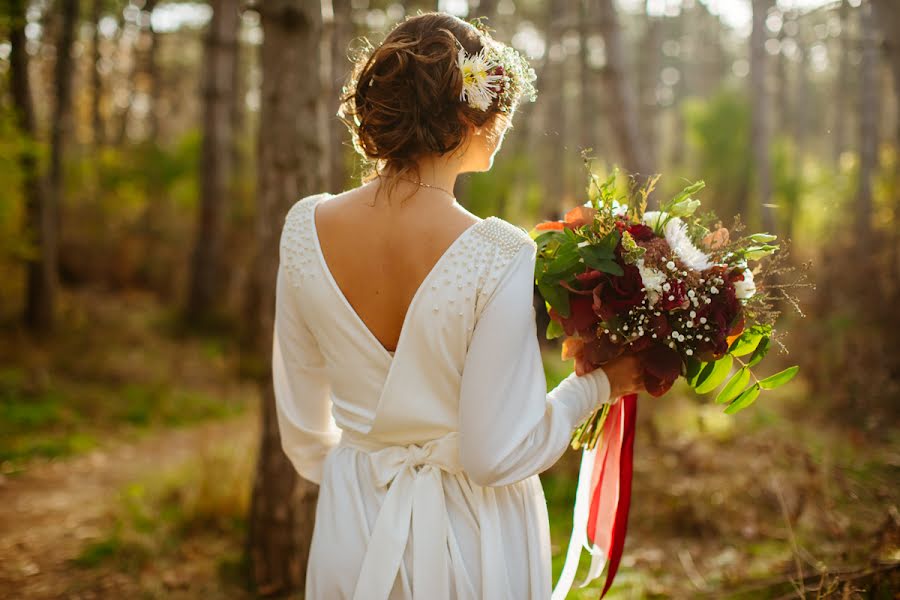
[[273, 194, 610, 600]]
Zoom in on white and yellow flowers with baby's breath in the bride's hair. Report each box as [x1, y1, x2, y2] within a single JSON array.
[[457, 30, 536, 112]]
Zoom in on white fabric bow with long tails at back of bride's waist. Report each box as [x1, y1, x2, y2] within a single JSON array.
[[341, 432, 462, 600]]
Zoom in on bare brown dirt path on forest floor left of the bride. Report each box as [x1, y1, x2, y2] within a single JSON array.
[[0, 415, 255, 600]]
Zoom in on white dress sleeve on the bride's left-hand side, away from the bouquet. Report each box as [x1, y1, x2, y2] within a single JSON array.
[[272, 263, 340, 483]]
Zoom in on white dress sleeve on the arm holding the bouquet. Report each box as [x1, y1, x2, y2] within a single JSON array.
[[459, 245, 614, 486]]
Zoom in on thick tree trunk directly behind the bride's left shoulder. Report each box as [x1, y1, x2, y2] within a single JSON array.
[[247, 0, 323, 593]]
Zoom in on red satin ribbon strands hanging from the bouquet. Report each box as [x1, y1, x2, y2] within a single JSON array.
[[587, 394, 637, 598]]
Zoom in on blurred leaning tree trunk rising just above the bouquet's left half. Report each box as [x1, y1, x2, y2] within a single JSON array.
[[597, 0, 652, 181]]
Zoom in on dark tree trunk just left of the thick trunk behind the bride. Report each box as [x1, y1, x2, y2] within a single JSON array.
[[187, 0, 241, 321]]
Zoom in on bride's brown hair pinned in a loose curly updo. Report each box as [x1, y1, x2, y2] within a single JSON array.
[[338, 12, 511, 200]]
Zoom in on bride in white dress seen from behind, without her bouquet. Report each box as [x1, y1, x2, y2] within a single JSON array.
[[273, 13, 642, 600]]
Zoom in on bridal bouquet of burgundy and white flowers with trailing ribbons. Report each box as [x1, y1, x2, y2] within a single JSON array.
[[531, 172, 798, 599]]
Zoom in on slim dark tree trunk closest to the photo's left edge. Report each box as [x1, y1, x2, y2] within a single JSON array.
[[8, 0, 57, 332]]
